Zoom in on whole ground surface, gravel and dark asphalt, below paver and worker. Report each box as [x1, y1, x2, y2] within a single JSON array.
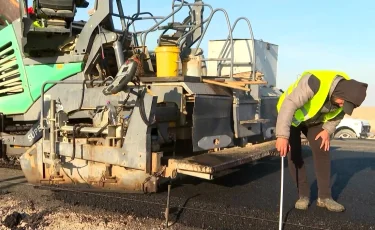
[[0, 140, 375, 230]]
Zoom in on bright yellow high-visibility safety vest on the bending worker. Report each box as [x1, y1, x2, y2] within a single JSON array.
[[277, 70, 350, 127]]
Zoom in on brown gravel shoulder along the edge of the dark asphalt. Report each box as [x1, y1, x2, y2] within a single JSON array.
[[0, 169, 198, 230]]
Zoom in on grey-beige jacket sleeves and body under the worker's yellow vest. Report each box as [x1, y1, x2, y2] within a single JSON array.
[[276, 74, 345, 138]]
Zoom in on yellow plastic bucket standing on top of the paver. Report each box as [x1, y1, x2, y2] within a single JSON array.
[[155, 46, 180, 77]]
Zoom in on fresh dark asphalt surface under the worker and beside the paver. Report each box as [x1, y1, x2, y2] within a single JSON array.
[[1, 140, 375, 229]]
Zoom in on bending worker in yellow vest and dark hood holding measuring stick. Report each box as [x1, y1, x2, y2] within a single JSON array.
[[276, 70, 368, 212]]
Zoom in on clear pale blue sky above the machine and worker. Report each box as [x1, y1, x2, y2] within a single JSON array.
[[69, 0, 375, 106]]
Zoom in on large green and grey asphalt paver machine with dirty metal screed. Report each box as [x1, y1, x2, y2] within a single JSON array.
[[0, 0, 281, 192]]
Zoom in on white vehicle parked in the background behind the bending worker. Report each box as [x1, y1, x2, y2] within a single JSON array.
[[333, 117, 374, 139]]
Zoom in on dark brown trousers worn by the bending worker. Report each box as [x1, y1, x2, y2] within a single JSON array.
[[287, 124, 331, 199]]
